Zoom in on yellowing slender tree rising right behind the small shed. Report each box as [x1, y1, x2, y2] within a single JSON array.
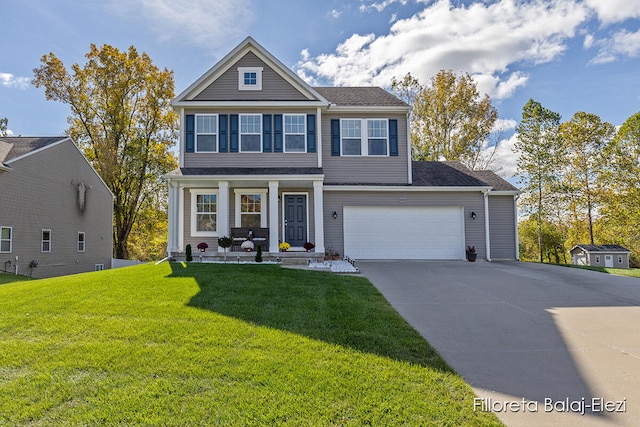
[[560, 111, 616, 245]]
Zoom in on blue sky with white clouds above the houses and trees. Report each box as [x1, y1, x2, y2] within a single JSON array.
[[0, 0, 640, 174]]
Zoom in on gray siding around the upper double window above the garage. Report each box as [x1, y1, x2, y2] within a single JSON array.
[[322, 113, 409, 184]]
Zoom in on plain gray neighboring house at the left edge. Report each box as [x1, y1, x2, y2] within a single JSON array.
[[0, 137, 113, 277]]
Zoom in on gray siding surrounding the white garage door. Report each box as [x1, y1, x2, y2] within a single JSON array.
[[324, 191, 487, 258]]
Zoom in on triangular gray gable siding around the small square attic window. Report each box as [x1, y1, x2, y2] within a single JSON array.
[[194, 52, 309, 101]]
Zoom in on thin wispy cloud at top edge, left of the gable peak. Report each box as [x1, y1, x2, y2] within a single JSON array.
[[110, 0, 254, 50]]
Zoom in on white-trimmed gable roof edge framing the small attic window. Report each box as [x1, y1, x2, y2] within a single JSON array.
[[173, 37, 329, 106]]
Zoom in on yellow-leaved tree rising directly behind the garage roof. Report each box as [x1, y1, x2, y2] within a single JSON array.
[[392, 70, 498, 169]]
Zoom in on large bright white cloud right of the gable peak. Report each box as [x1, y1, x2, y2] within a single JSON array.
[[297, 0, 590, 98]]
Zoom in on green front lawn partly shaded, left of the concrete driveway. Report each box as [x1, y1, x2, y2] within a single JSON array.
[[0, 263, 500, 426]]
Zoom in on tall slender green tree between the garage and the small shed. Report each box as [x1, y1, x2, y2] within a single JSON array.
[[515, 99, 564, 262]]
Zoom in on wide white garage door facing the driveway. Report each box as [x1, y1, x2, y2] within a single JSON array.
[[343, 206, 464, 259]]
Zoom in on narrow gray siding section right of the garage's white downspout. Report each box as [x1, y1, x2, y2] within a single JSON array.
[[489, 196, 516, 259]]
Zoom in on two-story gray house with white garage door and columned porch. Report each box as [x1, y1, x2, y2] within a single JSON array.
[[166, 37, 519, 260]]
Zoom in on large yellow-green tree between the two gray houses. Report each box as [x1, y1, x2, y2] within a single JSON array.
[[33, 44, 178, 258]]
